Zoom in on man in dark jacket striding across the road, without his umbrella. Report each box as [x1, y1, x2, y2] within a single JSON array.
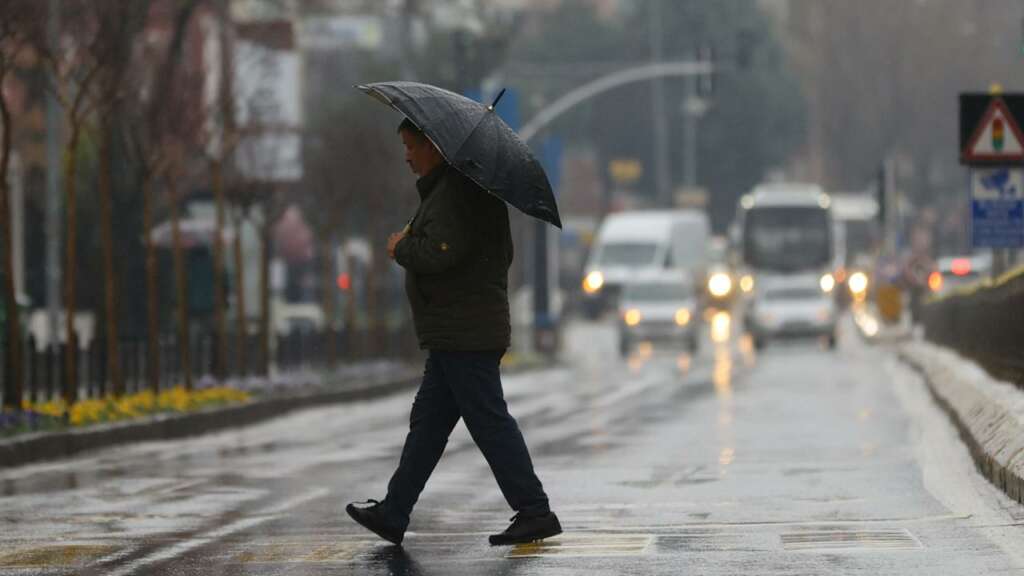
[[345, 119, 561, 545]]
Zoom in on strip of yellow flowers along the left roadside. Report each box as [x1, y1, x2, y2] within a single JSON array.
[[22, 386, 250, 426]]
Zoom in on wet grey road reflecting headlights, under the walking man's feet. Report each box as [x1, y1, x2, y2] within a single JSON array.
[[0, 315, 1024, 576]]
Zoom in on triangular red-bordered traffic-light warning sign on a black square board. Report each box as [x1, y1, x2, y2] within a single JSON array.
[[959, 94, 1024, 165]]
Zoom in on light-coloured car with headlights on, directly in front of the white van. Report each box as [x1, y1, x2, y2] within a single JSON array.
[[618, 273, 700, 357]]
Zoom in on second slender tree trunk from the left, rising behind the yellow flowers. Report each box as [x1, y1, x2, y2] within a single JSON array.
[[63, 121, 81, 408]]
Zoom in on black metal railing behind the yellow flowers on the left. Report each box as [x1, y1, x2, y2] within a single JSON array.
[[0, 326, 418, 403]]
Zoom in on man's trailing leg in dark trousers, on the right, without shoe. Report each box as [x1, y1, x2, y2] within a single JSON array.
[[436, 352, 550, 516]]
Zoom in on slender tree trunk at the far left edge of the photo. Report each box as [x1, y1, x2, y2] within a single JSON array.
[[0, 89, 24, 410]]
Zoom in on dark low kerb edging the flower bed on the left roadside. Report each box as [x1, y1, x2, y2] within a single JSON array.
[[0, 373, 421, 469]]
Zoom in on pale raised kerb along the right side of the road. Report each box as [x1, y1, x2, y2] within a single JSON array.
[[897, 345, 1024, 503]]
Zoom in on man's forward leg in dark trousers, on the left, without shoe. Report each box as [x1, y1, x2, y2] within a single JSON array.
[[384, 353, 459, 528]]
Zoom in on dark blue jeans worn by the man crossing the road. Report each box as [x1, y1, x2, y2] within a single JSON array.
[[384, 351, 549, 527]]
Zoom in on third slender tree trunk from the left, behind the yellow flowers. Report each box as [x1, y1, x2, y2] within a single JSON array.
[[98, 122, 125, 398]]
